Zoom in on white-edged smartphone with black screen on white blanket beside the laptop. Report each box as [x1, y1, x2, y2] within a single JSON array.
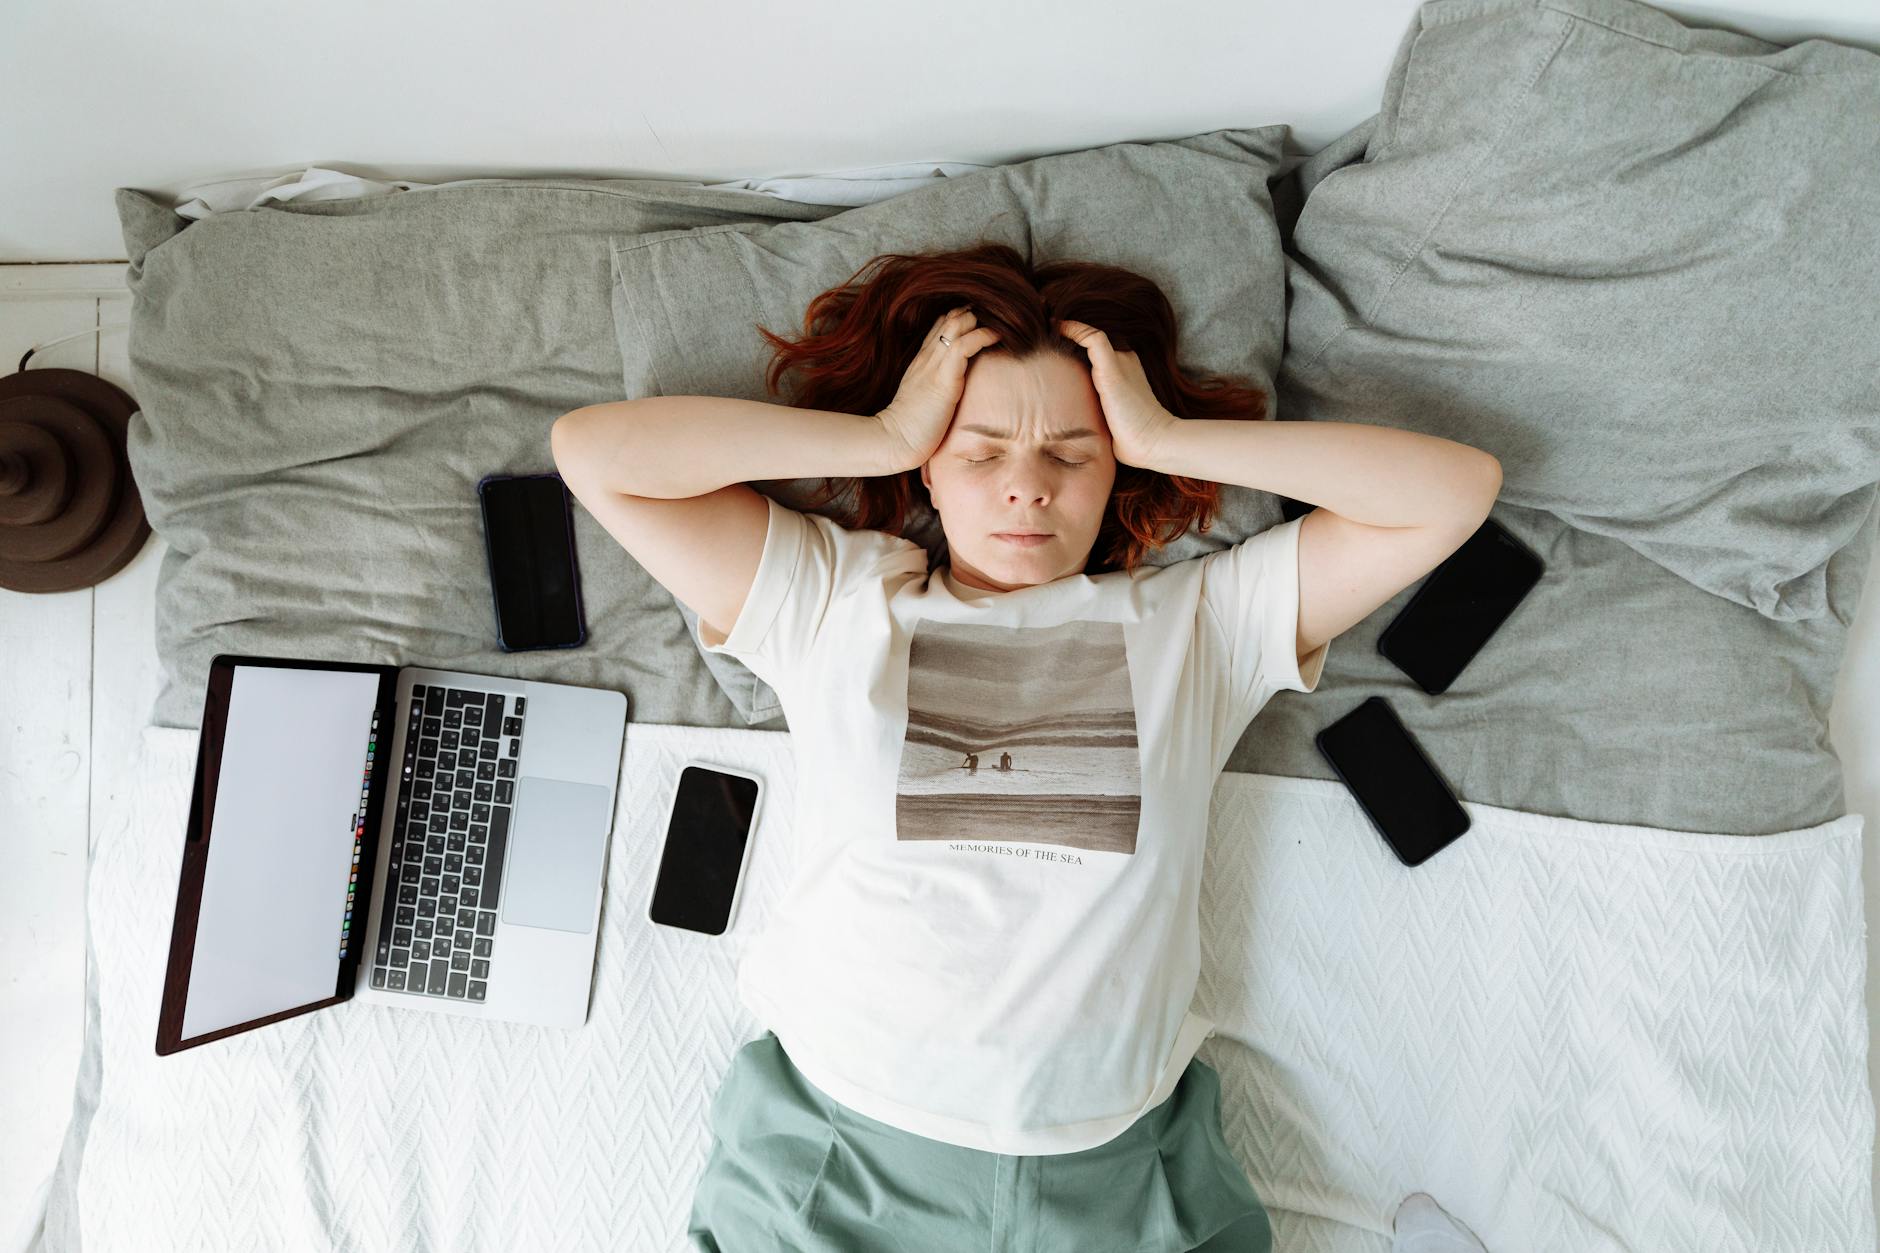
[[647, 760, 763, 935]]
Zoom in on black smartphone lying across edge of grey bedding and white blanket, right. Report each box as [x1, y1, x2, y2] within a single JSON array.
[[1314, 696, 1468, 865]]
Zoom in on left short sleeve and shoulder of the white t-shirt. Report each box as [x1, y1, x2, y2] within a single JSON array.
[[696, 497, 927, 692]]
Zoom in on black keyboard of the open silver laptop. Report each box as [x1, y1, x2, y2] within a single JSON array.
[[372, 683, 526, 1001]]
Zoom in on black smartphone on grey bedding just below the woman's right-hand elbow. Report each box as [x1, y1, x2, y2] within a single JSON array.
[[1378, 517, 1543, 696]]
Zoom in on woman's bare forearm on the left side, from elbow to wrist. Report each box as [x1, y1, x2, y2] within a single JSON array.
[[551, 395, 902, 500]]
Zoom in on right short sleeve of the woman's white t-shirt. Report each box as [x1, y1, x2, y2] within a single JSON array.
[[1201, 515, 1331, 721]]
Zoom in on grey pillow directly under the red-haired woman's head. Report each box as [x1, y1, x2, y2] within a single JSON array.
[[613, 126, 1292, 722]]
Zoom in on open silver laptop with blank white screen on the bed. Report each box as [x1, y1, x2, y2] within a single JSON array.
[[158, 655, 628, 1054]]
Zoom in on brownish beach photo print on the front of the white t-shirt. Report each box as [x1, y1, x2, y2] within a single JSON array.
[[895, 619, 1143, 852]]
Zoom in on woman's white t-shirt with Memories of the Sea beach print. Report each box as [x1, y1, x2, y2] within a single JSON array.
[[699, 497, 1329, 1153]]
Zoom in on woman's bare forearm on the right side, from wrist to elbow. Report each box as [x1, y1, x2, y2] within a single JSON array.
[[1149, 418, 1502, 527]]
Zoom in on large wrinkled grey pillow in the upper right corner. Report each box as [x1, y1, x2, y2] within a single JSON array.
[[1278, 0, 1880, 619]]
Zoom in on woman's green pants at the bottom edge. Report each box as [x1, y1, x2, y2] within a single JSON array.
[[686, 1031, 1273, 1253]]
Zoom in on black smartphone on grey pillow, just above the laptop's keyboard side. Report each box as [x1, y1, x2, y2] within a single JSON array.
[[476, 474, 587, 653]]
